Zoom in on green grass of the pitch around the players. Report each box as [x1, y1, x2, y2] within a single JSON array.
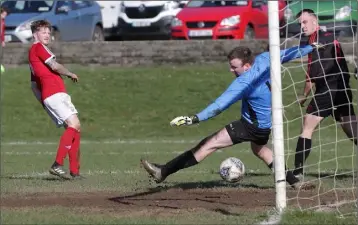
[[1, 64, 356, 224]]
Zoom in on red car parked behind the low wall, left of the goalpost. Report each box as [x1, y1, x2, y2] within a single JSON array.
[[171, 0, 286, 40]]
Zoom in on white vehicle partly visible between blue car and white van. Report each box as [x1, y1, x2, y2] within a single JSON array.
[[96, 1, 122, 38]]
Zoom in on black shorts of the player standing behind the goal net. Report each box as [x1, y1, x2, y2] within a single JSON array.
[[306, 84, 355, 121]]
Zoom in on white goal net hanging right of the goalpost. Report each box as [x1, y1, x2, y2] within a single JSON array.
[[269, 0, 358, 216]]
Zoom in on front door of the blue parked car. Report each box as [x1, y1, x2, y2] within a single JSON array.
[[55, 1, 81, 41]]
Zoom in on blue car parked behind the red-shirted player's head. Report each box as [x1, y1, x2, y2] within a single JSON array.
[[2, 0, 104, 43]]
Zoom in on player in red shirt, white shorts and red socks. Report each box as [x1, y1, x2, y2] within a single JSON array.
[[29, 20, 81, 179]]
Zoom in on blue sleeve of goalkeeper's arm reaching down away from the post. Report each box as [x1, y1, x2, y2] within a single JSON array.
[[196, 54, 269, 121]]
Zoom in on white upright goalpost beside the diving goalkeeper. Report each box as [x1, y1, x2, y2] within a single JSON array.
[[268, 1, 286, 211]]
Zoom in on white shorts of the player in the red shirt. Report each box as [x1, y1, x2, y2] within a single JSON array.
[[43, 93, 78, 127]]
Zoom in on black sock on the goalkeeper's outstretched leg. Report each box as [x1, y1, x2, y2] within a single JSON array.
[[162, 150, 198, 177]]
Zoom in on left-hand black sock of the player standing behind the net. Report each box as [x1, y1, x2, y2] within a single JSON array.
[[295, 137, 312, 173]]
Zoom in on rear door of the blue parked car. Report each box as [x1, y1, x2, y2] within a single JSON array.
[[73, 1, 97, 41]]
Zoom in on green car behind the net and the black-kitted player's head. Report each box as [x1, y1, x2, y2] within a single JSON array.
[[285, 0, 358, 36]]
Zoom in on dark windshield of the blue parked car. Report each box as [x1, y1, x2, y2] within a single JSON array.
[[1, 1, 53, 13]]
